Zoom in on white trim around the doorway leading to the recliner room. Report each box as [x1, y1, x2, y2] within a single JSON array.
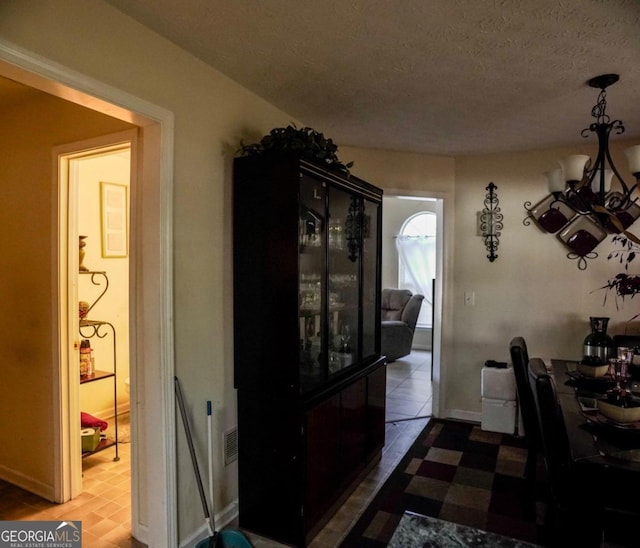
[[383, 189, 453, 417]]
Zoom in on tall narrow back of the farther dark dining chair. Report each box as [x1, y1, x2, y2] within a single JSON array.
[[509, 337, 540, 486]]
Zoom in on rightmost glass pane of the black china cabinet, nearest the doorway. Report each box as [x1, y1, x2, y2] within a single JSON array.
[[361, 199, 380, 360]]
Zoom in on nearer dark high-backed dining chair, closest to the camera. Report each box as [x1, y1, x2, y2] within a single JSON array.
[[528, 358, 604, 548]]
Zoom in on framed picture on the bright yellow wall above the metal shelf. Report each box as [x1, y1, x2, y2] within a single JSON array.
[[100, 182, 129, 258]]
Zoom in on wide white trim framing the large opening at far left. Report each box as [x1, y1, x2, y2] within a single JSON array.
[[0, 40, 178, 548]]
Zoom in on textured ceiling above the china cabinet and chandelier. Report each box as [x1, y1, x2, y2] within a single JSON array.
[[16, 0, 640, 155]]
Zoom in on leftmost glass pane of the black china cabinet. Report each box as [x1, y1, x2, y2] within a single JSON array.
[[298, 175, 326, 392]]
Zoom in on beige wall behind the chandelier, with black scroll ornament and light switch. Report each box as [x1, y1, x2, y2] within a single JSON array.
[[446, 141, 638, 412]]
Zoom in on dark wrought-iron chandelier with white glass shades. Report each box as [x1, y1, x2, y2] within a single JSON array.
[[523, 74, 640, 270]]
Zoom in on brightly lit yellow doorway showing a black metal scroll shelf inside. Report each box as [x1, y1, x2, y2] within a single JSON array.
[[58, 139, 136, 498]]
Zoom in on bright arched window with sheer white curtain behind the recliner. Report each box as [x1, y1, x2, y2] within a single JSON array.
[[396, 211, 437, 327]]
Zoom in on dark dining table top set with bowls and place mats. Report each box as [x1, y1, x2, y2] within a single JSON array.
[[549, 359, 640, 476]]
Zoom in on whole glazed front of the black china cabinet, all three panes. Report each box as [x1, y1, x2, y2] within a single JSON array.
[[298, 169, 381, 393]]
